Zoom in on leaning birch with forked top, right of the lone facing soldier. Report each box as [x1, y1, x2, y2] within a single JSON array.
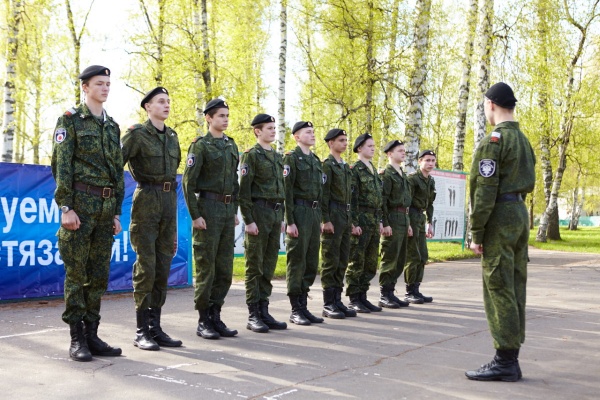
[[536, 0, 600, 242]]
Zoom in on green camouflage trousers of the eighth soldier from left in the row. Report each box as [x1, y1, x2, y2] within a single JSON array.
[[379, 211, 408, 286]]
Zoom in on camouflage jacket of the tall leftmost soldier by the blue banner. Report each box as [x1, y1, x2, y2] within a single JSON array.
[[52, 104, 125, 215]]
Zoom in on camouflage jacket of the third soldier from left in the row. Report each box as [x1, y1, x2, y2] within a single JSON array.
[[183, 132, 240, 220]]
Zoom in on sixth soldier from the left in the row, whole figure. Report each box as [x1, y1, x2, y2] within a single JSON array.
[[321, 129, 356, 318]]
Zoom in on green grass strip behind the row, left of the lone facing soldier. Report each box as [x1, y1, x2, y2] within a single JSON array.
[[233, 242, 475, 281]]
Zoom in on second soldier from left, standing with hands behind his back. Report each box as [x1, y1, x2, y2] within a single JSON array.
[[122, 86, 182, 350]]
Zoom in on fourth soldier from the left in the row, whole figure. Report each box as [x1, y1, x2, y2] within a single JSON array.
[[240, 114, 287, 332]]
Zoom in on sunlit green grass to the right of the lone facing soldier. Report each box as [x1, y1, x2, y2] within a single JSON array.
[[529, 227, 600, 253]]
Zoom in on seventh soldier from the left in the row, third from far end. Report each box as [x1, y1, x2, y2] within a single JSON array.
[[346, 133, 383, 313]]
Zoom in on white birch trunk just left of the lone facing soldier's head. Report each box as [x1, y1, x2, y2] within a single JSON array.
[[473, 0, 494, 149]]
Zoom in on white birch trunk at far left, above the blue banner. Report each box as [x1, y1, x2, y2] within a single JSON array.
[[2, 0, 23, 162]]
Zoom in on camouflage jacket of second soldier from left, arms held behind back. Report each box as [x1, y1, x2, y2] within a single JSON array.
[[122, 120, 181, 183]]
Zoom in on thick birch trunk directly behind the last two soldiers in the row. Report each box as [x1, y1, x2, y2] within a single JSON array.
[[405, 0, 431, 172]]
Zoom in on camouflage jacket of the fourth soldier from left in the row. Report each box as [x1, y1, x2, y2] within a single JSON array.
[[239, 143, 285, 224]]
